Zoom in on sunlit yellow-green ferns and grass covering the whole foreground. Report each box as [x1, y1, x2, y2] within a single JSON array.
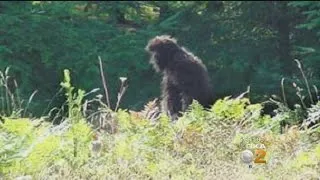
[[0, 70, 320, 179]]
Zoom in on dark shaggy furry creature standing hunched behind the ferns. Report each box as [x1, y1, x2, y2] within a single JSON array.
[[145, 35, 213, 119]]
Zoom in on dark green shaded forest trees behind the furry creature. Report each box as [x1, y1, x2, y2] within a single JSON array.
[[0, 1, 320, 116]]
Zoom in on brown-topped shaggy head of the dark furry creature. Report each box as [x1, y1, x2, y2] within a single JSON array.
[[145, 35, 180, 72]]
